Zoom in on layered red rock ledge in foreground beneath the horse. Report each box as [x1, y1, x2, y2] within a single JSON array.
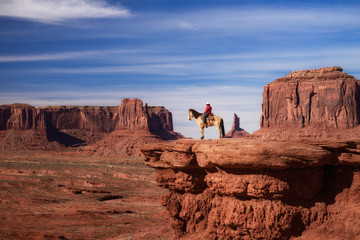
[[142, 139, 360, 239]]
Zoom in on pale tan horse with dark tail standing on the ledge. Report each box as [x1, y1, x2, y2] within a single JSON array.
[[189, 109, 225, 139]]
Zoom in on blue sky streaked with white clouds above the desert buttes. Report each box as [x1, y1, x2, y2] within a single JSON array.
[[0, 0, 360, 139]]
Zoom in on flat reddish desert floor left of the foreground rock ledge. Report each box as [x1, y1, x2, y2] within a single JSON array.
[[0, 152, 174, 240]]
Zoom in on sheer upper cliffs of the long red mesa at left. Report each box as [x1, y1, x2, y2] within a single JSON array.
[[0, 98, 173, 134]]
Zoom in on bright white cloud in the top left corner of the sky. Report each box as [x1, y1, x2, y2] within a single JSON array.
[[0, 0, 130, 23]]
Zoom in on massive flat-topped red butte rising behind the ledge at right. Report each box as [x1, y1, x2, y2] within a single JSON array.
[[254, 67, 360, 139]]
